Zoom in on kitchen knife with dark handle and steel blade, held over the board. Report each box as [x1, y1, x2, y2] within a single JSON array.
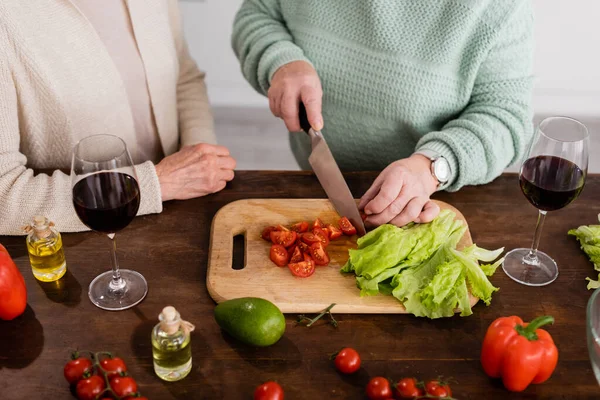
[[299, 102, 366, 236]]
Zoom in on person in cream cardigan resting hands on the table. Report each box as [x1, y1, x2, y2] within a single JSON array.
[[0, 0, 235, 235]]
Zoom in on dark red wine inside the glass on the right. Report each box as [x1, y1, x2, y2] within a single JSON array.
[[519, 156, 585, 211]]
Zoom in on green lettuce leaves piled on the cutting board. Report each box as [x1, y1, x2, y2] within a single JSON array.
[[342, 210, 504, 318]]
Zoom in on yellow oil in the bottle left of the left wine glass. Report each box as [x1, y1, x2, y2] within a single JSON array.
[[27, 236, 67, 282]]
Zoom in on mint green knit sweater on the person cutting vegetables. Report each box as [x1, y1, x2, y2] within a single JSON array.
[[232, 0, 534, 190]]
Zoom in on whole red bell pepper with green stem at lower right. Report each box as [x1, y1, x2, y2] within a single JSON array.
[[481, 316, 558, 392]]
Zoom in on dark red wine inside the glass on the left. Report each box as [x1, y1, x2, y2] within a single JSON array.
[[73, 172, 140, 233]]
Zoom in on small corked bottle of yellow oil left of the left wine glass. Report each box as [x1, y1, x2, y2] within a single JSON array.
[[25, 216, 67, 282]]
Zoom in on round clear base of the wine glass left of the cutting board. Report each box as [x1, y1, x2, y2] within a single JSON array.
[[88, 269, 148, 311]]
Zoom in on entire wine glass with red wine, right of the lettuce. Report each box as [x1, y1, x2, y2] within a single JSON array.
[[502, 117, 589, 286]]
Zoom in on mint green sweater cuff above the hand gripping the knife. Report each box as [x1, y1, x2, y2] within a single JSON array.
[[258, 41, 312, 94]]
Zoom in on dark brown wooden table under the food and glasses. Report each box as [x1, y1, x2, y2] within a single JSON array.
[[0, 172, 600, 400]]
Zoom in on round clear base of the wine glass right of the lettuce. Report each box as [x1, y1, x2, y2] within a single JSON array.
[[502, 249, 558, 286]]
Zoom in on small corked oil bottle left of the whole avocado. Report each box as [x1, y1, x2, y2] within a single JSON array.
[[152, 306, 194, 382]]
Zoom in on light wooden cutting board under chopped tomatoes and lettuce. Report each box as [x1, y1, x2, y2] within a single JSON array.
[[206, 199, 478, 314]]
